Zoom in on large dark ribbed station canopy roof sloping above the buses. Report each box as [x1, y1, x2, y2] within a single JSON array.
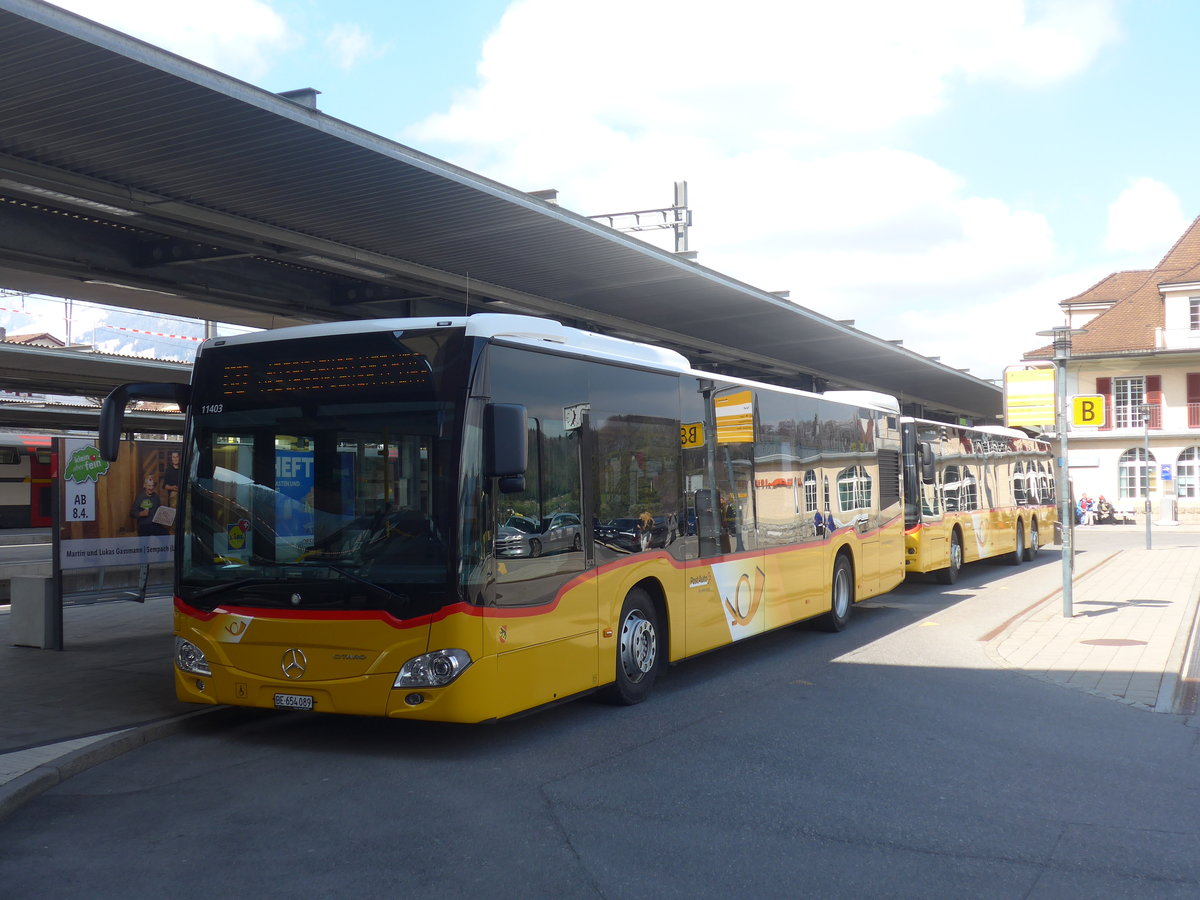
[[0, 0, 1002, 422]]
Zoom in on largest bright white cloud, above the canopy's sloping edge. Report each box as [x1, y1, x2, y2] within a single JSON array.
[[404, 0, 1123, 377]]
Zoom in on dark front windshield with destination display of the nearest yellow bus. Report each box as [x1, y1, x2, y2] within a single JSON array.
[[179, 331, 464, 617]]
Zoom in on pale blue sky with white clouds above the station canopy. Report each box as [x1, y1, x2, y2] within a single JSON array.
[[16, 0, 1200, 378]]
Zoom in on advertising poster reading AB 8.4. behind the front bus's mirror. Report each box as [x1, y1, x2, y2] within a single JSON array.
[[59, 438, 180, 581]]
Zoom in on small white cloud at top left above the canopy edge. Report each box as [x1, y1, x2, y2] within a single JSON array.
[[52, 0, 292, 80]]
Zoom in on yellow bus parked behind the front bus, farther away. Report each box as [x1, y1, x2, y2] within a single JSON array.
[[901, 416, 1058, 584]]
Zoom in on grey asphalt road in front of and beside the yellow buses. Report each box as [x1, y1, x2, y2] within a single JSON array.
[[0, 532, 1200, 899]]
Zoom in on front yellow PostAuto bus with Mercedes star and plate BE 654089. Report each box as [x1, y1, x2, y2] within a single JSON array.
[[101, 314, 905, 722]]
